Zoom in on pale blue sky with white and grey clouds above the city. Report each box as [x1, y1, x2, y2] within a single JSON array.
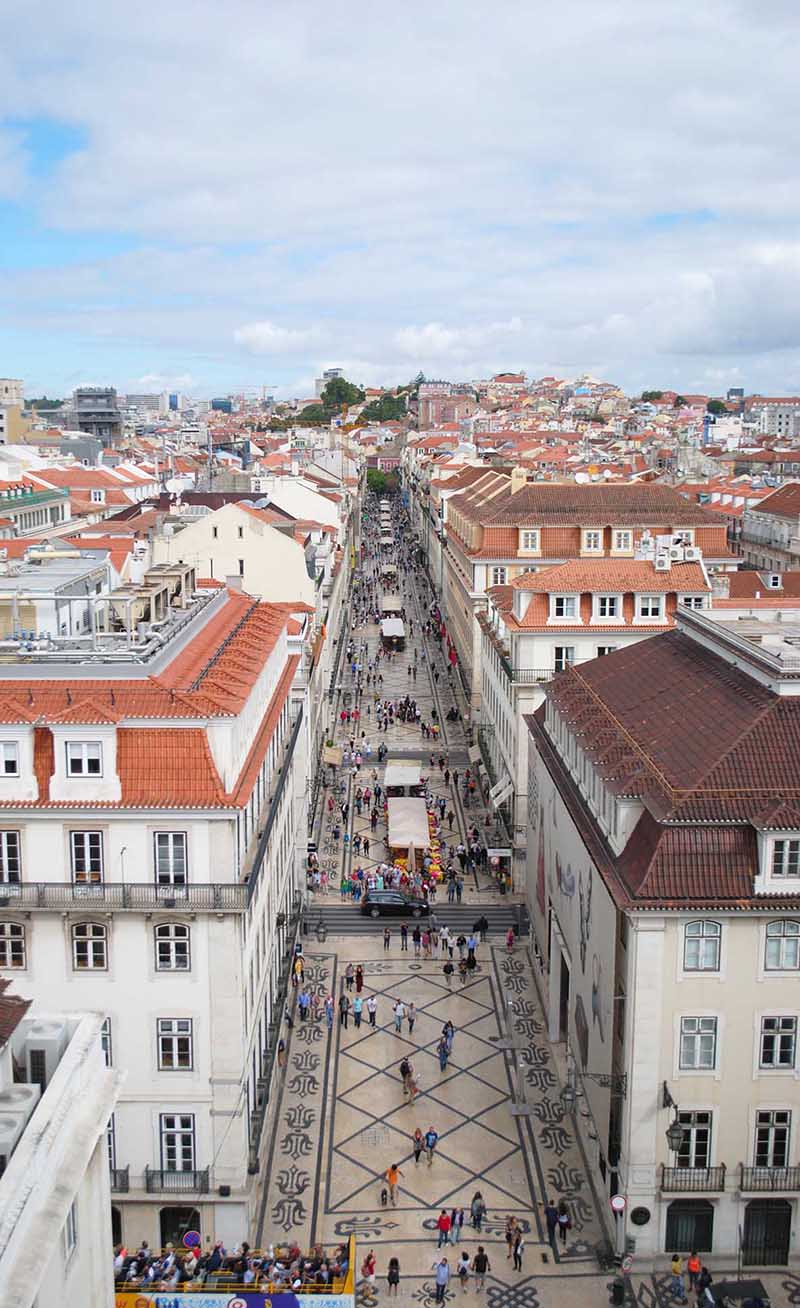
[[0, 0, 800, 396]]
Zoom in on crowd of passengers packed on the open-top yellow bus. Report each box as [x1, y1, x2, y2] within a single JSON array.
[[114, 1240, 349, 1295]]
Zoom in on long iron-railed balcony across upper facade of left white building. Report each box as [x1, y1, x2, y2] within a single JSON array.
[[0, 882, 247, 913]]
